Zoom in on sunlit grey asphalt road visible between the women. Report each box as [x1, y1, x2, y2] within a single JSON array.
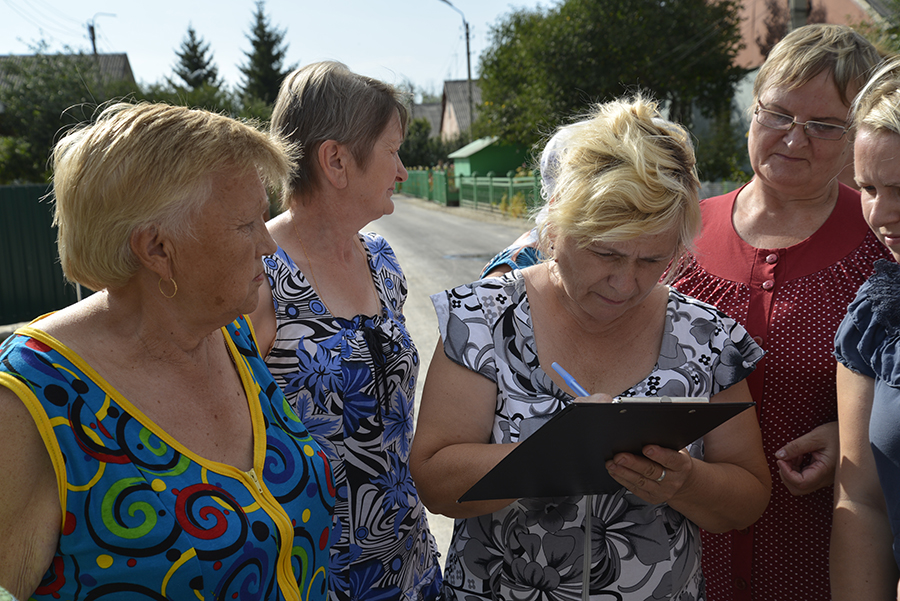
[[363, 194, 532, 563]]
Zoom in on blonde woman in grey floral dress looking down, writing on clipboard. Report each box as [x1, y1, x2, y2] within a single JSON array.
[[410, 97, 771, 601]]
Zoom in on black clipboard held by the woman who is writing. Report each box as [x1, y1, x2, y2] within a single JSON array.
[[459, 402, 755, 502]]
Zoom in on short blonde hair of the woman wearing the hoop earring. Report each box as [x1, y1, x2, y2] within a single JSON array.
[[52, 103, 294, 290]]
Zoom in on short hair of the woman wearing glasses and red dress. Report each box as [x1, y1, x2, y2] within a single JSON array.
[[753, 23, 881, 106]]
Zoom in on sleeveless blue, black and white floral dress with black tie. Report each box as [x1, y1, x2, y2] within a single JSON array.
[[264, 234, 441, 601]]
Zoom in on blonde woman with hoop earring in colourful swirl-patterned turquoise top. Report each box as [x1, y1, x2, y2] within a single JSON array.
[[0, 104, 335, 601]]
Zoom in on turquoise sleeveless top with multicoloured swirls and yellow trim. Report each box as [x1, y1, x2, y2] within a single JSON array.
[[0, 318, 335, 601]]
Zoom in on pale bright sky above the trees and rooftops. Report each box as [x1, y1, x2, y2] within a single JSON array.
[[0, 0, 554, 95]]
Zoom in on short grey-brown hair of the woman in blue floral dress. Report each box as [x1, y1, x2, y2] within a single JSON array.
[[272, 61, 409, 209]]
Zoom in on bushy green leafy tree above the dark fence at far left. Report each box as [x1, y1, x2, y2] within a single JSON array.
[[0, 42, 136, 184]]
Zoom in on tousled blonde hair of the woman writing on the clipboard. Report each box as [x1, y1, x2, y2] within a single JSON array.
[[540, 96, 700, 266]]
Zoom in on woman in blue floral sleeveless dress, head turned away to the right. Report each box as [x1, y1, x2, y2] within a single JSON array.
[[251, 62, 441, 601]]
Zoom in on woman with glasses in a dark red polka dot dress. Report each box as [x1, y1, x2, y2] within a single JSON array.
[[675, 25, 890, 601]]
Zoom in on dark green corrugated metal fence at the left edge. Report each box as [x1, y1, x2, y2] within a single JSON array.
[[0, 185, 76, 324]]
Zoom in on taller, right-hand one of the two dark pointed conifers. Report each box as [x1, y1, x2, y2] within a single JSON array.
[[240, 0, 295, 105]]
